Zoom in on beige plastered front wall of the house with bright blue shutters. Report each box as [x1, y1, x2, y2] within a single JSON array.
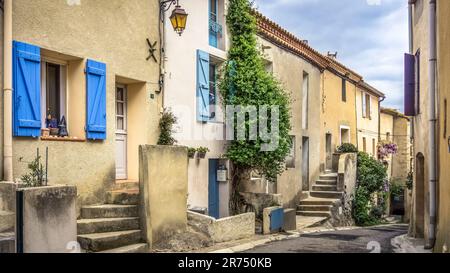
[[0, 0, 161, 208]]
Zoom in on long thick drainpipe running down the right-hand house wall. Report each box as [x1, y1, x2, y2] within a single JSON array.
[[426, 0, 437, 249]]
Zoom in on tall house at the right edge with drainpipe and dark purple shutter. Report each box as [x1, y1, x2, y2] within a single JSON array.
[[405, 0, 450, 252]]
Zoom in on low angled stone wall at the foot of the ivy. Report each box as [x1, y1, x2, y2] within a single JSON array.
[[188, 211, 255, 243]]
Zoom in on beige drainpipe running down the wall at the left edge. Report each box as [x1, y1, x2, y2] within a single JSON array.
[[3, 0, 13, 182]]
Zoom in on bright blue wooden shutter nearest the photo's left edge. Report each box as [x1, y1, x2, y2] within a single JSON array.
[[13, 41, 41, 137]]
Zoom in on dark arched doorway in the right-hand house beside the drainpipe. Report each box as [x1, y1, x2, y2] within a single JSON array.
[[414, 153, 425, 238]]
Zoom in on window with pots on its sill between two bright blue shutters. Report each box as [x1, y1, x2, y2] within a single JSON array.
[[41, 60, 67, 128]]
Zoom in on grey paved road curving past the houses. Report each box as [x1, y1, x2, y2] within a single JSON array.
[[245, 225, 408, 253]]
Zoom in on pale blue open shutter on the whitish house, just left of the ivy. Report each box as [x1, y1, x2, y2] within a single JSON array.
[[197, 50, 210, 122]]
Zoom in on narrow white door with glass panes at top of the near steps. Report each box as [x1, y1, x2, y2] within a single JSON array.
[[116, 85, 128, 180]]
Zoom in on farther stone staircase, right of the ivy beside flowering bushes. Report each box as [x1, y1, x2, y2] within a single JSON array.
[[297, 173, 343, 221]]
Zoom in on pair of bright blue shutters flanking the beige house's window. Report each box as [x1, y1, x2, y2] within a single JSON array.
[[13, 41, 106, 139]]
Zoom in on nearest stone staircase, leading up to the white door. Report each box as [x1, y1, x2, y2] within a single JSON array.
[[77, 181, 148, 253]]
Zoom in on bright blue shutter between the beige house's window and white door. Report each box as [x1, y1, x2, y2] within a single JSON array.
[[86, 60, 106, 140]]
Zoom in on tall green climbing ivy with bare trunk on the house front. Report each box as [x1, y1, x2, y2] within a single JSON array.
[[219, 0, 292, 213]]
